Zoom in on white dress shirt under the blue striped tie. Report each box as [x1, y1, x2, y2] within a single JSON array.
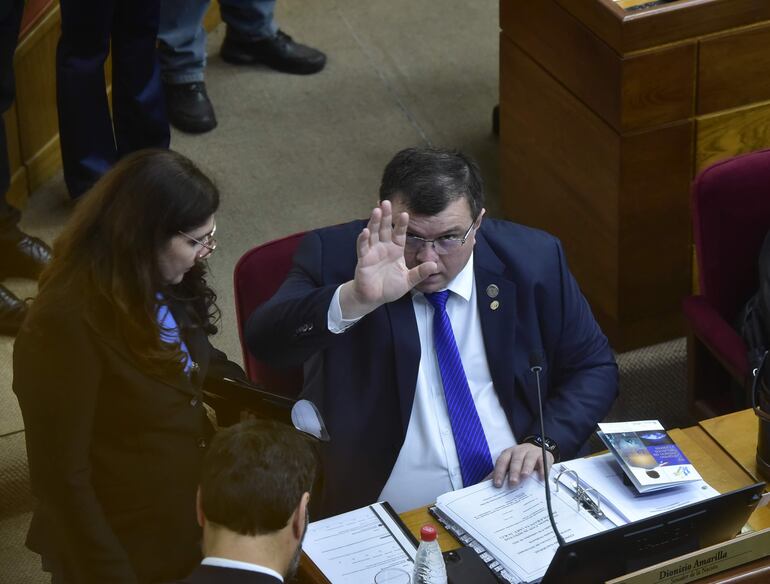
[[328, 254, 516, 513]]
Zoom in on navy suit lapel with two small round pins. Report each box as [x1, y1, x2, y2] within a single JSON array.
[[473, 232, 537, 435]]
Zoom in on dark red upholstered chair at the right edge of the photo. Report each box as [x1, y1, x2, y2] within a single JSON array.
[[683, 150, 770, 418]]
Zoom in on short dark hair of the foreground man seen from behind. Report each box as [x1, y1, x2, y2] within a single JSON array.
[[200, 420, 317, 535]]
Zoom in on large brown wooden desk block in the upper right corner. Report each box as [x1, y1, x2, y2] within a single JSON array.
[[500, 0, 770, 351]]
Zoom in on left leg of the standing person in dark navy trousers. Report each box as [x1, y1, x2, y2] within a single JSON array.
[[56, 0, 121, 199]]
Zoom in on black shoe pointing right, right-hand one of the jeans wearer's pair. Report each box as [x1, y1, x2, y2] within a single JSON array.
[[220, 27, 326, 75]]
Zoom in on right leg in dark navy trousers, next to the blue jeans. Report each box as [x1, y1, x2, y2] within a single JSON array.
[[112, 0, 170, 158]]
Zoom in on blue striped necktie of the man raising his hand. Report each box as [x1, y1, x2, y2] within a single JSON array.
[[425, 290, 493, 487]]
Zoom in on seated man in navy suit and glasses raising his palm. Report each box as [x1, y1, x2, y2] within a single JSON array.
[[246, 148, 617, 515]]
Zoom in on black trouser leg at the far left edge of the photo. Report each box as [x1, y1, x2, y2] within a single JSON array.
[[0, 0, 24, 243]]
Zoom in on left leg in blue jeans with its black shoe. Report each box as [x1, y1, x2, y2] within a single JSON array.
[[158, 0, 217, 134]]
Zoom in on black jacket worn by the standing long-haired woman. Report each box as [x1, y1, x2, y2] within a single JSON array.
[[13, 286, 239, 584]]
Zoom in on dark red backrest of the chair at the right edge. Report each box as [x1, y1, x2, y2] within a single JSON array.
[[692, 149, 770, 322]]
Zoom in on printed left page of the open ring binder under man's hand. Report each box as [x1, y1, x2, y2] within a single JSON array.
[[436, 476, 610, 582]]
